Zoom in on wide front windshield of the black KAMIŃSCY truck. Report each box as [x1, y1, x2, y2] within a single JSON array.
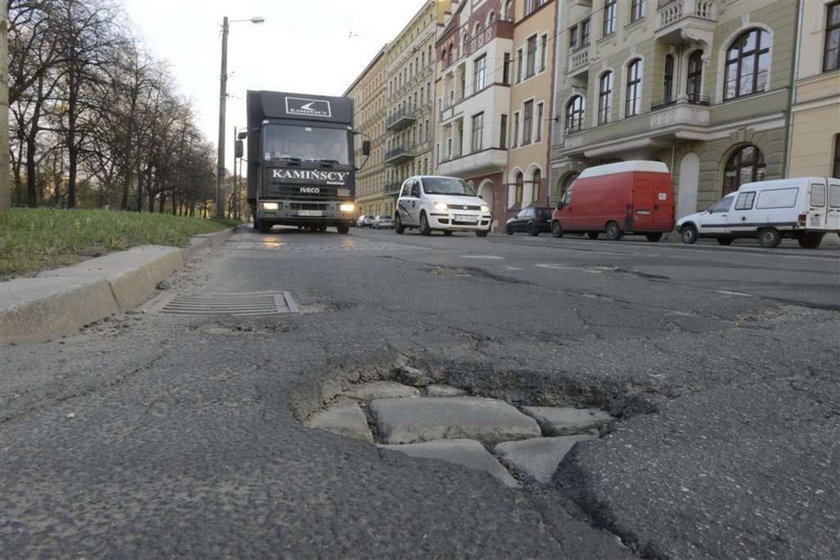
[[263, 125, 350, 165]]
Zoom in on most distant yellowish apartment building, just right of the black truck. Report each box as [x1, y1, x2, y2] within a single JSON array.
[[344, 45, 388, 219]]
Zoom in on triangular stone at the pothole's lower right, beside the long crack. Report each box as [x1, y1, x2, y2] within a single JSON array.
[[493, 435, 598, 484]]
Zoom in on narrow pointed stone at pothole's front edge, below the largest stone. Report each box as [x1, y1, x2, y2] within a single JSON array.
[[380, 439, 519, 488]]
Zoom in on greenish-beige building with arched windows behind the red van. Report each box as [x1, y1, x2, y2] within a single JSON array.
[[550, 0, 810, 216]]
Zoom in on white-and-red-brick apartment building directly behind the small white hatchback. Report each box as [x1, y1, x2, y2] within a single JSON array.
[[435, 0, 514, 224]]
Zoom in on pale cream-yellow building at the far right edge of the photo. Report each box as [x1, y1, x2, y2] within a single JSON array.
[[788, 0, 840, 178]]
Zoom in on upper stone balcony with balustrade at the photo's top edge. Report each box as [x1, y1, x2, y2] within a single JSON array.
[[654, 0, 717, 45]]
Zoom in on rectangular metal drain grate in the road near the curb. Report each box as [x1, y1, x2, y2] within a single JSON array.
[[157, 292, 300, 317]]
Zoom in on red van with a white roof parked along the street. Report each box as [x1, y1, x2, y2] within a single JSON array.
[[551, 161, 674, 241]]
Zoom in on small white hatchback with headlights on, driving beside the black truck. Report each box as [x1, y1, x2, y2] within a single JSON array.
[[394, 175, 492, 237]]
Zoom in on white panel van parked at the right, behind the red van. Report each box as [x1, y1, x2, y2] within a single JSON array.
[[677, 177, 840, 249]]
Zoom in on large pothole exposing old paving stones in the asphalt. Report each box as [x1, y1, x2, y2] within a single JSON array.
[[292, 359, 632, 488]]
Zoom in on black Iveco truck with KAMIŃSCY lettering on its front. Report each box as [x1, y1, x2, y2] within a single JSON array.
[[237, 91, 370, 233]]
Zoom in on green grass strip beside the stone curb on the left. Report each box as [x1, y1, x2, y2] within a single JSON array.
[[0, 208, 235, 280]]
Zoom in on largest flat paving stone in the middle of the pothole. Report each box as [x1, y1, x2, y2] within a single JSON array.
[[370, 397, 542, 445]]
